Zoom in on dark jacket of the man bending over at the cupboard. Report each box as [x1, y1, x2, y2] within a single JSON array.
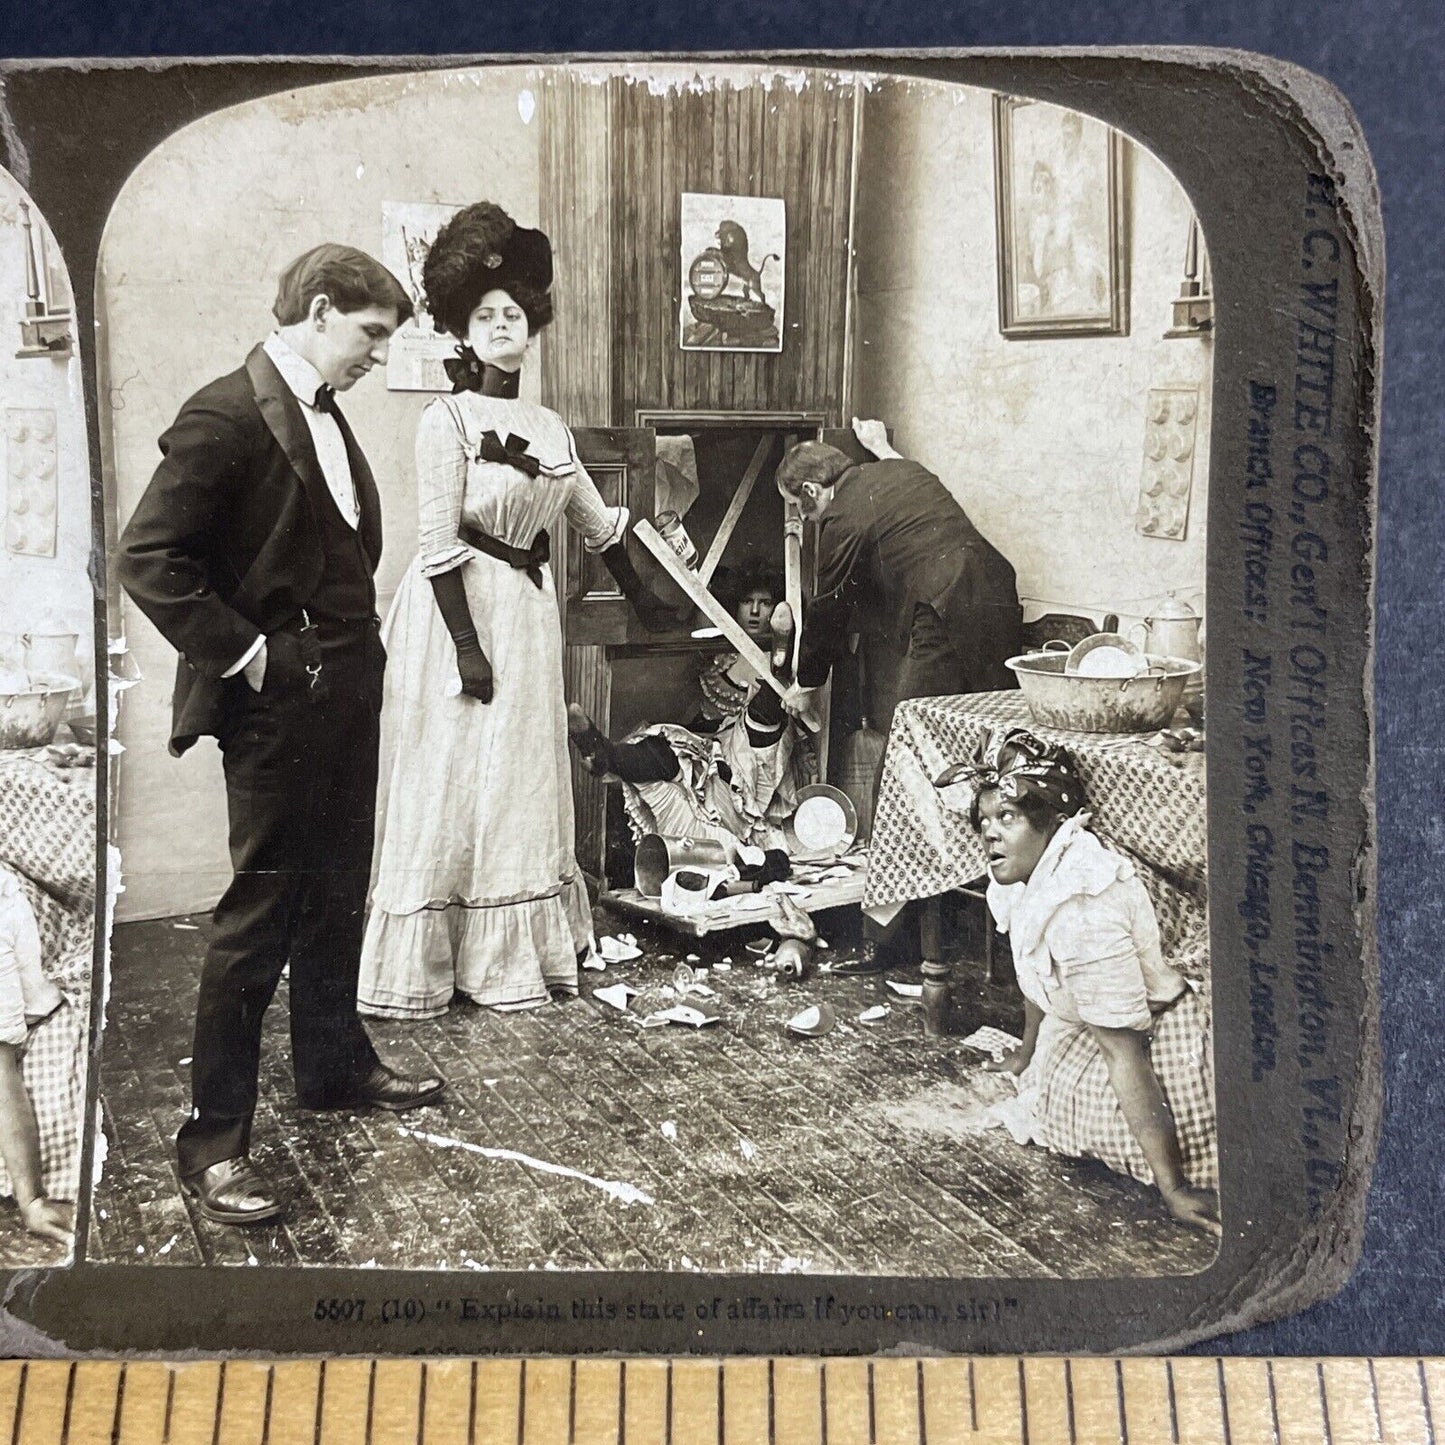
[[799, 458, 1019, 685]]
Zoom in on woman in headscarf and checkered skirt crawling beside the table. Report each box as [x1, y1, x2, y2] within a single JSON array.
[[959, 728, 1220, 1234]]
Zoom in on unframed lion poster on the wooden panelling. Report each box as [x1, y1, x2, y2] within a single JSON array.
[[679, 191, 788, 351]]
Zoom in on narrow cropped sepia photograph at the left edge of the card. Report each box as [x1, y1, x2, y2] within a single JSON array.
[[0, 171, 97, 1269]]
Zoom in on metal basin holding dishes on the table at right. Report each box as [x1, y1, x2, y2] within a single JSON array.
[[1006, 652, 1199, 733]]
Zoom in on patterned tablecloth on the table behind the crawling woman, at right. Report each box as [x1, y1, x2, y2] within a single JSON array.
[[863, 692, 1208, 981]]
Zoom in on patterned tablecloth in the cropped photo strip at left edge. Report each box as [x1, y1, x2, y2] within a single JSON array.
[[0, 751, 95, 1012]]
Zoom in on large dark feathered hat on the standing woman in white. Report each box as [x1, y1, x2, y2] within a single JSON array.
[[422, 201, 552, 340]]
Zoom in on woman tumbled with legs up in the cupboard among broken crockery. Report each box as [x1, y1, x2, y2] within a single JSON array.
[[568, 591, 814, 884]]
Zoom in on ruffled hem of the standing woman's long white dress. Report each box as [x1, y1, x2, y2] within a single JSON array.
[[357, 887, 591, 1019]]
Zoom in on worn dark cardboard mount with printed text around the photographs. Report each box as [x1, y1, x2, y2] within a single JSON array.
[[0, 49, 1384, 1357]]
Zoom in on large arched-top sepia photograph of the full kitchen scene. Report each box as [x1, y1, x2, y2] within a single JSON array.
[[87, 62, 1231, 1279]]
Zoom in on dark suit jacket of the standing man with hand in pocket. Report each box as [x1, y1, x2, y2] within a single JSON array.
[[116, 347, 381, 756]]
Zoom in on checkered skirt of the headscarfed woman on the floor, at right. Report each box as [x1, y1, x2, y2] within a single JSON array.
[[1030, 990, 1220, 1189]]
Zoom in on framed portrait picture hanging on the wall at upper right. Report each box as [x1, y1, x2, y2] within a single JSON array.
[[994, 95, 1129, 337]]
